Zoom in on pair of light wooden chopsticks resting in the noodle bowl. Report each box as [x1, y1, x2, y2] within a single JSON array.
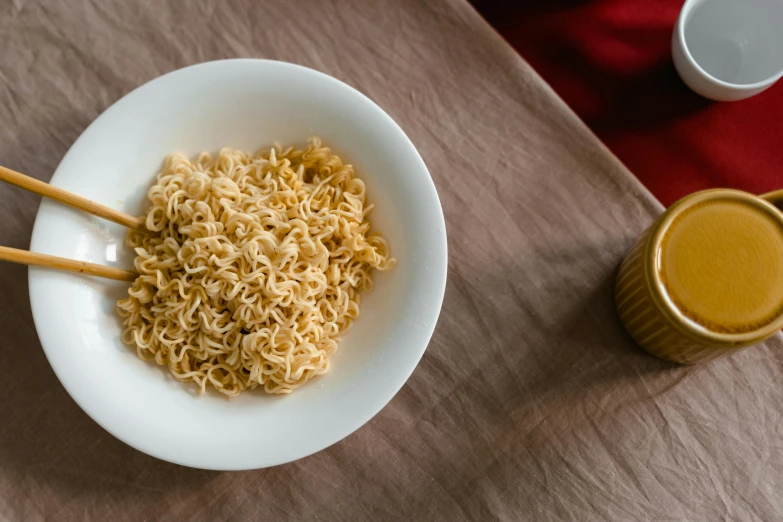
[[0, 166, 146, 281]]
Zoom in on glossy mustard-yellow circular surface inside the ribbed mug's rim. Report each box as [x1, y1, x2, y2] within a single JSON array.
[[658, 198, 783, 333]]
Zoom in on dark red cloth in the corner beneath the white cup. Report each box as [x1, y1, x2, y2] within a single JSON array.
[[474, 0, 783, 205]]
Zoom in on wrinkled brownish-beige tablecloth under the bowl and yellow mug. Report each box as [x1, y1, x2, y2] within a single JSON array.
[[0, 0, 783, 521]]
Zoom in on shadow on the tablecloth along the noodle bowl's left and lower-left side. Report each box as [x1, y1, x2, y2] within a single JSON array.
[[0, 115, 225, 498]]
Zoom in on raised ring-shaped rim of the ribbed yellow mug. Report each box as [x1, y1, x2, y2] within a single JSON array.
[[645, 189, 783, 348]]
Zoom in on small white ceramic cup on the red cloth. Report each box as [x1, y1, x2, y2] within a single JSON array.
[[672, 0, 783, 101]]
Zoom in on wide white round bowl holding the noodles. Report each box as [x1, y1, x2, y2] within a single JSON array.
[[30, 60, 447, 470]]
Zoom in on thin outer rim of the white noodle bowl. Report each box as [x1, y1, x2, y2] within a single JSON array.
[[28, 58, 448, 471]]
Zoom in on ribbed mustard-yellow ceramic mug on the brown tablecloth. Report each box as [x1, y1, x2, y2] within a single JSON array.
[[615, 189, 783, 364]]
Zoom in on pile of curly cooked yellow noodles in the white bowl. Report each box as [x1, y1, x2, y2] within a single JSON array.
[[118, 138, 394, 396]]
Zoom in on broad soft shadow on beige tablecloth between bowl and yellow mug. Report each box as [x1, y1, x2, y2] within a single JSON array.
[[386, 238, 698, 508]]
